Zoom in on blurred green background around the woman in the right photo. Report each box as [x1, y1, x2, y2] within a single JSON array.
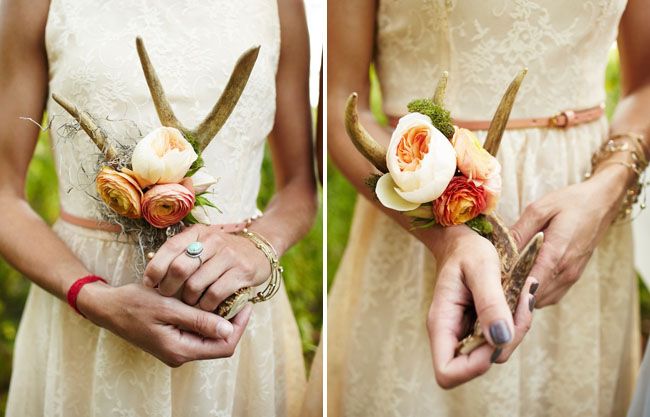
[[327, 48, 650, 332]]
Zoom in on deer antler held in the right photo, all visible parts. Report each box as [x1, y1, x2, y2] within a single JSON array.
[[345, 69, 544, 354]]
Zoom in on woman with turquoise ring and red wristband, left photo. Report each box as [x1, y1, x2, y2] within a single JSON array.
[[0, 0, 316, 417]]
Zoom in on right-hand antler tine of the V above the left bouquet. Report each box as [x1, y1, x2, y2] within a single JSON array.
[[194, 45, 260, 150]]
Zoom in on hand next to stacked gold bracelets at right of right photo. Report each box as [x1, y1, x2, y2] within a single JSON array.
[[511, 165, 630, 307]]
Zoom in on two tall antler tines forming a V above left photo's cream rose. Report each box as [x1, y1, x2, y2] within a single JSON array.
[[135, 37, 260, 151]]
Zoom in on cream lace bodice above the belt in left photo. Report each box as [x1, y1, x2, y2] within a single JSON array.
[[46, 0, 280, 223]]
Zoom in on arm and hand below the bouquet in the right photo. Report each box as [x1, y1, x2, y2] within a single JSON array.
[[327, 0, 531, 388]]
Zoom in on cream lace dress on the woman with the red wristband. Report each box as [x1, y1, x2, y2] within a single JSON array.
[[7, 0, 305, 417]]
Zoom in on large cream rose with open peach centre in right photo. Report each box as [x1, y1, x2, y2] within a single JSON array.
[[375, 113, 456, 211]]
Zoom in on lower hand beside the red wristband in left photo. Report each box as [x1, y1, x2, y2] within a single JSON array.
[[77, 283, 252, 367]]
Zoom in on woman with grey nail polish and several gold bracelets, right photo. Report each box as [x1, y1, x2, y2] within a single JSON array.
[[328, 0, 650, 416]]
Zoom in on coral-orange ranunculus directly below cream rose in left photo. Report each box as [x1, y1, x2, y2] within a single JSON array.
[[142, 183, 195, 229]]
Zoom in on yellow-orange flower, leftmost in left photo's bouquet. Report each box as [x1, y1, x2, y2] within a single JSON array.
[[95, 166, 142, 219]]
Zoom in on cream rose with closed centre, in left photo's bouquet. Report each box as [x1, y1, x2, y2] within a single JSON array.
[[131, 127, 198, 188]]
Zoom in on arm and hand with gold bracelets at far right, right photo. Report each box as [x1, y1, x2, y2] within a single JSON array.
[[513, 0, 650, 307]]
